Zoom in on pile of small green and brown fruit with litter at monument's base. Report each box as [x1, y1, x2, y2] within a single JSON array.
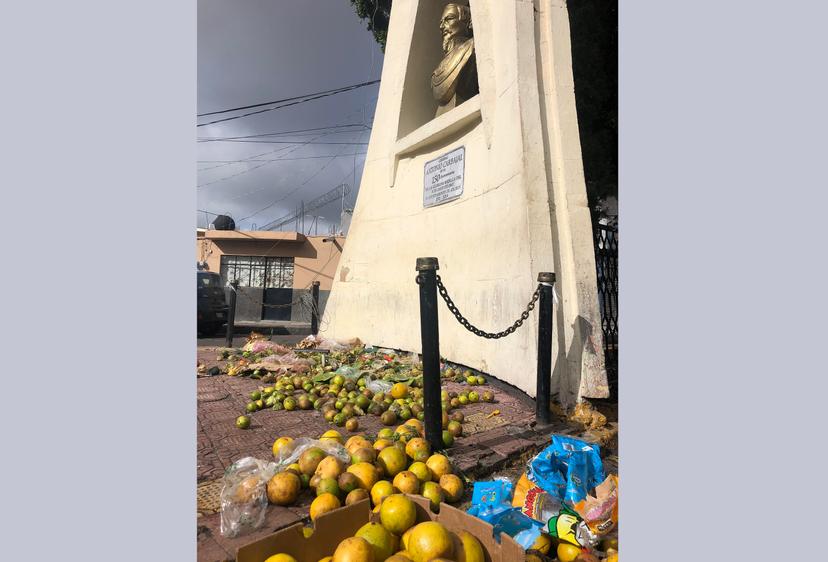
[[222, 336, 495, 438]]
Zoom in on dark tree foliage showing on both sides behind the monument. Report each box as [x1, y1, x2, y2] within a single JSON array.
[[350, 0, 618, 219]]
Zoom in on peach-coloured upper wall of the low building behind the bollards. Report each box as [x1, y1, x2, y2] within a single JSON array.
[[196, 233, 345, 291]]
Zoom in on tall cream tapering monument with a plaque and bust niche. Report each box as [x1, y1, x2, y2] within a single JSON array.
[[321, 0, 609, 405]]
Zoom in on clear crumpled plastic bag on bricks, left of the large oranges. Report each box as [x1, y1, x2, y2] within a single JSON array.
[[220, 457, 277, 537]]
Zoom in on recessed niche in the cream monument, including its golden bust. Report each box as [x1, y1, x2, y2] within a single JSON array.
[[397, 0, 479, 140]]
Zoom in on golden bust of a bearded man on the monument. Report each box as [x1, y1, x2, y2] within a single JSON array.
[[431, 3, 479, 115]]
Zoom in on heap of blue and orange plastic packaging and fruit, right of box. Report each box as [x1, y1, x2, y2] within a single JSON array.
[[468, 435, 618, 562]]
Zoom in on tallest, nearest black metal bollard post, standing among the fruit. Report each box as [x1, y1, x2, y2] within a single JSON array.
[[416, 258, 444, 451]]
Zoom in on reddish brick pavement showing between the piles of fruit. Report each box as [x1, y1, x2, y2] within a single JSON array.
[[197, 347, 616, 562]]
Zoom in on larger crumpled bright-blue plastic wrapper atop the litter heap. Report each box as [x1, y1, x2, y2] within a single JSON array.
[[526, 435, 604, 505]]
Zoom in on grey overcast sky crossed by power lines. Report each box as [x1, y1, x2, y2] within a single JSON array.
[[196, 0, 382, 234]]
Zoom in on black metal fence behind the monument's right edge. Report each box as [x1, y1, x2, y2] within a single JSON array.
[[593, 224, 618, 397]]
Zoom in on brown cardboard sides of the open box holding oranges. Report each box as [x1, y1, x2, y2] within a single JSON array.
[[236, 496, 525, 562]]
